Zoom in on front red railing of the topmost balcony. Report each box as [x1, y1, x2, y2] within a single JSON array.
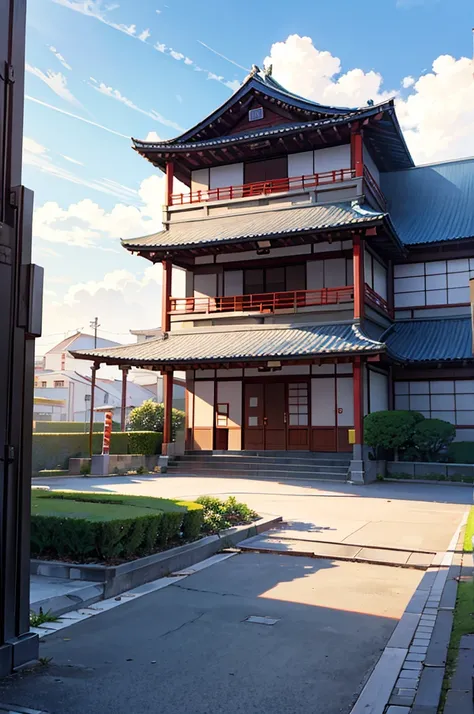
[[170, 169, 355, 206]]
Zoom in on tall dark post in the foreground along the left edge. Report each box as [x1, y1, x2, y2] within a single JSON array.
[[0, 0, 43, 676]]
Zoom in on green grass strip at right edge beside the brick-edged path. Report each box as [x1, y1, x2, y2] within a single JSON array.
[[438, 508, 474, 714]]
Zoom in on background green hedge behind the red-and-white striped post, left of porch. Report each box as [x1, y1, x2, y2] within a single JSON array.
[[32, 431, 162, 476]]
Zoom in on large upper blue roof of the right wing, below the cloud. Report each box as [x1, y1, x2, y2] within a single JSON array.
[[380, 158, 474, 245]]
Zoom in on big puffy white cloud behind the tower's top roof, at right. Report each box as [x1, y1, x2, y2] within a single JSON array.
[[264, 35, 474, 163]]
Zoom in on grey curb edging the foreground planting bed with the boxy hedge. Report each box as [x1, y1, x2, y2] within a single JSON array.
[[30, 516, 282, 615]]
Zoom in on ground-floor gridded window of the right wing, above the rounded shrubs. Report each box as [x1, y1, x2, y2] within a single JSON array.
[[395, 379, 474, 426]]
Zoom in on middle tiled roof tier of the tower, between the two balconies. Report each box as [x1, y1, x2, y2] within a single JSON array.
[[122, 203, 385, 250]]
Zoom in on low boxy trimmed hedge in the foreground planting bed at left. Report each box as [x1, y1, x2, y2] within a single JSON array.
[[31, 489, 203, 561]]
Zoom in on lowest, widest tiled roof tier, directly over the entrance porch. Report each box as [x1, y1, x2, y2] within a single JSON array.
[[74, 324, 384, 365]]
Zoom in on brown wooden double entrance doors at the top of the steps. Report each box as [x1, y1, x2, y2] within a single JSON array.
[[244, 381, 309, 451]]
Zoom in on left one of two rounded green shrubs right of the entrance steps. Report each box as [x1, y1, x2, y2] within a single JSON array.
[[364, 410, 424, 461]]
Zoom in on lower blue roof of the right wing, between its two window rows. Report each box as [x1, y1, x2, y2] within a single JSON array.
[[386, 317, 473, 362]]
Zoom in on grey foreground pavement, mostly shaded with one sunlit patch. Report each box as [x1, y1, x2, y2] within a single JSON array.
[[0, 554, 421, 714]]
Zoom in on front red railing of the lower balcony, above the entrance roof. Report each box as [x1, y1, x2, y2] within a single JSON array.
[[170, 285, 354, 315]]
